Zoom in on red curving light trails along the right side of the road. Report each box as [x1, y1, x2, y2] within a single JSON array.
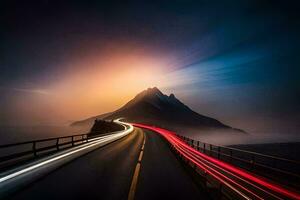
[[133, 124, 300, 199]]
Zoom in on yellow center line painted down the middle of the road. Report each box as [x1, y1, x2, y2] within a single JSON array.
[[128, 131, 146, 200]]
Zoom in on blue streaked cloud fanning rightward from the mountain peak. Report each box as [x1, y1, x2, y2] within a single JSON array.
[[160, 47, 267, 89]]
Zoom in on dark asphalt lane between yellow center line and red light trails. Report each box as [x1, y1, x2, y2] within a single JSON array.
[[135, 130, 209, 200]]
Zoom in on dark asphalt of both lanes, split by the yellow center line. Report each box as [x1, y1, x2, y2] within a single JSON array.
[[6, 129, 208, 200]]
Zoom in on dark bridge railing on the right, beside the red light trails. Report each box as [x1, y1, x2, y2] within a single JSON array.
[[177, 135, 300, 190]]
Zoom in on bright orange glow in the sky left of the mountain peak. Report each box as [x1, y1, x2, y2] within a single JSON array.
[[6, 51, 171, 124]]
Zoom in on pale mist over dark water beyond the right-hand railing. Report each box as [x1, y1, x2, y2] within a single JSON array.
[[174, 127, 300, 160]]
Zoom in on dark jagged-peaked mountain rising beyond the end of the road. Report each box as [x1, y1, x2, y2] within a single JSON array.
[[72, 87, 242, 132]]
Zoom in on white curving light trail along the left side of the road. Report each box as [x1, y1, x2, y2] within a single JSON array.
[[0, 120, 133, 186]]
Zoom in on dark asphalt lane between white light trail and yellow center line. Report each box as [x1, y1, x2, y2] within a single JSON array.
[[7, 130, 143, 200]]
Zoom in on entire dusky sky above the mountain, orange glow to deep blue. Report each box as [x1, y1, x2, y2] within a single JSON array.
[[0, 0, 300, 133]]
